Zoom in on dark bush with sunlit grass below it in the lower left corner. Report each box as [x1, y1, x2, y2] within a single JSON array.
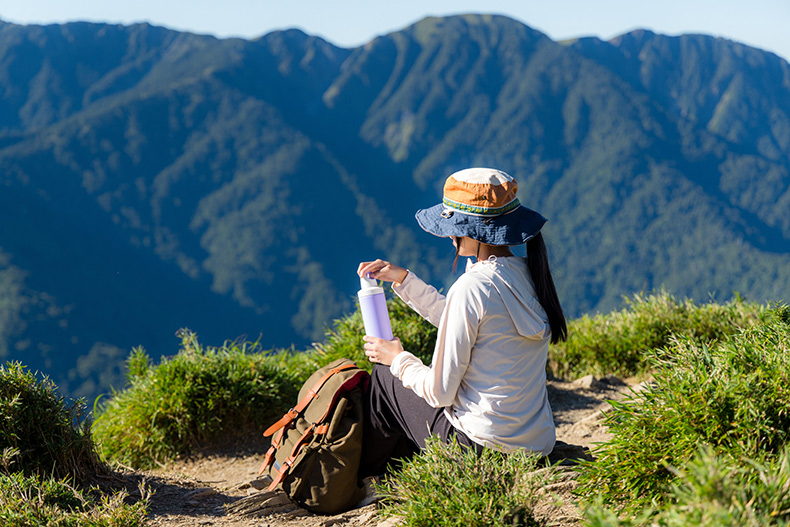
[[0, 363, 146, 527]]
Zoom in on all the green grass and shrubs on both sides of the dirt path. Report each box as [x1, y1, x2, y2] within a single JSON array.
[[0, 294, 790, 527]]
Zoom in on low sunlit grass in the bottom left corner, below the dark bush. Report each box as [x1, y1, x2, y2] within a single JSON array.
[[0, 472, 146, 527]]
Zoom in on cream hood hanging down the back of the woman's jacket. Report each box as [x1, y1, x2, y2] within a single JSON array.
[[466, 256, 551, 339]]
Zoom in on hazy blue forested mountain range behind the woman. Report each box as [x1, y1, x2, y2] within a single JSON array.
[[0, 15, 790, 395]]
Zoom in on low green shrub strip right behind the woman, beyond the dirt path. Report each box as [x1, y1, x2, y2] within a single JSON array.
[[549, 292, 765, 379]]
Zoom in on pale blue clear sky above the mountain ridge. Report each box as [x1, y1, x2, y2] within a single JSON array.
[[0, 0, 790, 60]]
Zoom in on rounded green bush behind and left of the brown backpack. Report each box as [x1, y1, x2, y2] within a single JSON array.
[[94, 330, 301, 467]]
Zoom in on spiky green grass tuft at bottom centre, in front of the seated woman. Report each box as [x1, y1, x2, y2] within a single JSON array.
[[377, 439, 548, 527]]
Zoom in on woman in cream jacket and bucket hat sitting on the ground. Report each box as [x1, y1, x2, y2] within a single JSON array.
[[358, 168, 567, 477]]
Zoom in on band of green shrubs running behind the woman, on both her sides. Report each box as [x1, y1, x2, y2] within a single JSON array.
[[94, 293, 766, 467]]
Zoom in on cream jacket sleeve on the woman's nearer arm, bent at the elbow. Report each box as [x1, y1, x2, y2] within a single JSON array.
[[390, 276, 483, 408]]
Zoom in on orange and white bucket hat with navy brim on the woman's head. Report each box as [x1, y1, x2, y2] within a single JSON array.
[[415, 168, 546, 245]]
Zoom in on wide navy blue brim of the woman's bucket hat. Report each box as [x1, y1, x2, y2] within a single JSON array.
[[415, 203, 546, 249]]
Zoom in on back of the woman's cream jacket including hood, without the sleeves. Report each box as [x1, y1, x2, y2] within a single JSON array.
[[448, 256, 555, 453]]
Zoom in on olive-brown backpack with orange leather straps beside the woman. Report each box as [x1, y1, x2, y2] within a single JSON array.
[[259, 359, 370, 514]]
